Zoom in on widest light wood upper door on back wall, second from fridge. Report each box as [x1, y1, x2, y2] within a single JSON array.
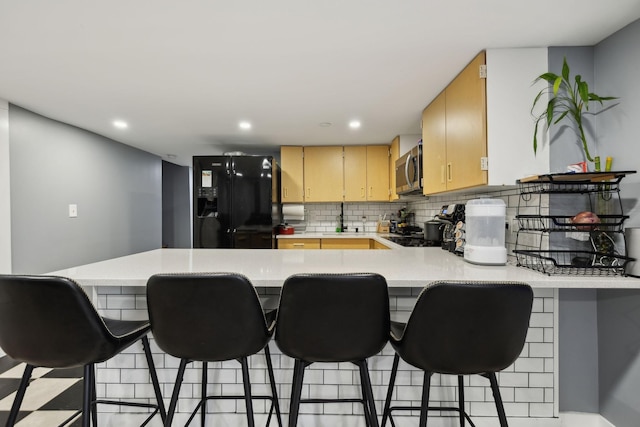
[[304, 146, 344, 202]]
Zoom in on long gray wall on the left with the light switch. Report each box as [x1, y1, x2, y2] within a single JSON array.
[[9, 105, 162, 273]]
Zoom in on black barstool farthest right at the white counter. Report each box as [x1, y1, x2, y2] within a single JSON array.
[[382, 282, 533, 427]]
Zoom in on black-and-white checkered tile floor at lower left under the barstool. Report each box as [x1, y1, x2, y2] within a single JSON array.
[[0, 356, 82, 427]]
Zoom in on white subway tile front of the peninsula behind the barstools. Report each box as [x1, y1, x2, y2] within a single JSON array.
[[92, 270, 556, 417]]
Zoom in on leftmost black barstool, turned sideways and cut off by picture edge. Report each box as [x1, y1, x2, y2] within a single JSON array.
[[0, 275, 166, 427]]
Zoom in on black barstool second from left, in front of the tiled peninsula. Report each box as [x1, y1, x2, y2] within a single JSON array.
[[147, 273, 282, 427]]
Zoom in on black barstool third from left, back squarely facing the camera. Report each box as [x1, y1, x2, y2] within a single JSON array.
[[276, 274, 389, 427]]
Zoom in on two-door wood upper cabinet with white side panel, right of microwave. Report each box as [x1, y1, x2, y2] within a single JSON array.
[[422, 48, 550, 194]]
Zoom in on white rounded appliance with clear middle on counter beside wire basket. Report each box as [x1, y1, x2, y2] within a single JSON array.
[[464, 199, 507, 265]]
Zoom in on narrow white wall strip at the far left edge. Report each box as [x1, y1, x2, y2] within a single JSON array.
[[0, 99, 11, 274]]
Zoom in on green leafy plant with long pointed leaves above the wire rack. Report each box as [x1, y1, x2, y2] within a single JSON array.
[[531, 57, 617, 171]]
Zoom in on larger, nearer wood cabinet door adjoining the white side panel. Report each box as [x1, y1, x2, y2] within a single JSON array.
[[445, 52, 487, 190]]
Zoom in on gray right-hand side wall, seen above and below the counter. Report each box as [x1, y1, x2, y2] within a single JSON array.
[[595, 21, 640, 427]]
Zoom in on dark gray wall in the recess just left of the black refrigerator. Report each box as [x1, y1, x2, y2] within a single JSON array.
[[162, 161, 191, 248]]
